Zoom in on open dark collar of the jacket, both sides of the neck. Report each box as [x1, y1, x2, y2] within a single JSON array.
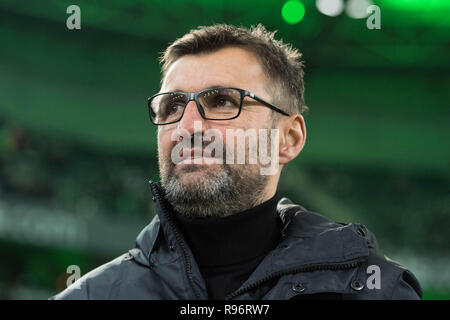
[[129, 181, 370, 270]]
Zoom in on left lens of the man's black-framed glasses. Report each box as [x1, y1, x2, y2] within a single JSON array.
[[149, 92, 187, 124]]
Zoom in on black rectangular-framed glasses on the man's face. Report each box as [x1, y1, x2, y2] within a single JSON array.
[[148, 87, 289, 125]]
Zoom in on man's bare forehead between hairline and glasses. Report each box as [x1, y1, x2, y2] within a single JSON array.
[[161, 47, 266, 94]]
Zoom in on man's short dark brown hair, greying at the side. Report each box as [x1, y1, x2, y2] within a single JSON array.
[[160, 24, 308, 114]]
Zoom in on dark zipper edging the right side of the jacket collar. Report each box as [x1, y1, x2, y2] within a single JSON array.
[[225, 258, 365, 300]]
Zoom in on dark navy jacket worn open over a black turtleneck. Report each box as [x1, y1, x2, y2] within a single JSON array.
[[50, 182, 422, 300]]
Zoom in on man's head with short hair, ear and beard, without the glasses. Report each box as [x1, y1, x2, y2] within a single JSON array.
[[154, 25, 306, 216]]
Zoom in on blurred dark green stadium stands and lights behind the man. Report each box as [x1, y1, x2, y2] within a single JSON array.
[[0, 0, 450, 299]]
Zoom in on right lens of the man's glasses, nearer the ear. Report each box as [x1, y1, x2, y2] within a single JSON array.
[[198, 88, 241, 119]]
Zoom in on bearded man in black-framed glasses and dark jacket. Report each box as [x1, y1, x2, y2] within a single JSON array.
[[52, 25, 422, 299]]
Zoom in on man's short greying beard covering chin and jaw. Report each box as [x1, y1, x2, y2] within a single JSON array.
[[161, 160, 268, 218]]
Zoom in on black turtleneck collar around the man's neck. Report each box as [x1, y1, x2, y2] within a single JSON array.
[[175, 193, 281, 268]]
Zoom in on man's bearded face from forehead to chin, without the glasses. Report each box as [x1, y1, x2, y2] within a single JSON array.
[[158, 48, 280, 216]]
